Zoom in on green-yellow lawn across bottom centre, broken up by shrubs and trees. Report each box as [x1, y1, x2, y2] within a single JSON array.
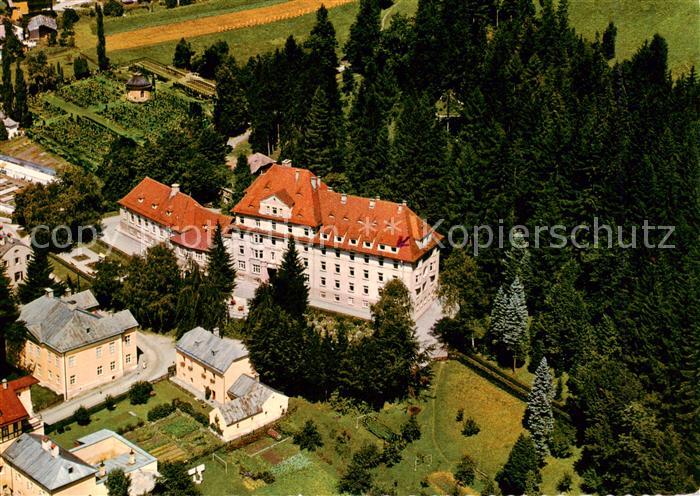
[[186, 361, 580, 496]]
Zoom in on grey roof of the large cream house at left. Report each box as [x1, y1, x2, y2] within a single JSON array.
[[19, 295, 139, 352]]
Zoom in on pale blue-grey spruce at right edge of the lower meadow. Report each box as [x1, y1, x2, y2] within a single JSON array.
[[524, 357, 554, 460]]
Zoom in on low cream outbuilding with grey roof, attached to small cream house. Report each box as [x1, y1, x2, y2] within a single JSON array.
[[209, 374, 289, 441]]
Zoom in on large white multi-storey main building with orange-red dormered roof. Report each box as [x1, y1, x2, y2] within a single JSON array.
[[230, 164, 440, 318]]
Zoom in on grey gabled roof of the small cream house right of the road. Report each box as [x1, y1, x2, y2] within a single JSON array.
[[175, 327, 248, 374]]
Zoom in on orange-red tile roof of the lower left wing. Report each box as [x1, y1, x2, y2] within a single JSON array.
[[119, 177, 232, 250]]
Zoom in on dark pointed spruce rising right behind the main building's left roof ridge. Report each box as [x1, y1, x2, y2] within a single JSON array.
[[299, 86, 340, 176]]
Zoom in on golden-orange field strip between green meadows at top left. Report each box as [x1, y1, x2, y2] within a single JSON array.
[[107, 0, 355, 51]]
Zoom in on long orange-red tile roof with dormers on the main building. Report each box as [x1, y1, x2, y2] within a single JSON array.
[[233, 164, 441, 262]]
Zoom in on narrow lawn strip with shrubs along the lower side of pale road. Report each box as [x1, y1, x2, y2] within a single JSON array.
[[51, 380, 208, 448]]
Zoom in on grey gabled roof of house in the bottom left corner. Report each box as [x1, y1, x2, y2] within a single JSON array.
[[0, 433, 97, 492]]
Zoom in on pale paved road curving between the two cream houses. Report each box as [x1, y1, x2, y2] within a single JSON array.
[[39, 332, 175, 424]]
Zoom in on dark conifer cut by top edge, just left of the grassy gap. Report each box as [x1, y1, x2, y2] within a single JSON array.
[[345, 0, 381, 74]]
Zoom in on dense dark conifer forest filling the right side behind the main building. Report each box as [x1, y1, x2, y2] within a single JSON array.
[[211, 0, 700, 493]]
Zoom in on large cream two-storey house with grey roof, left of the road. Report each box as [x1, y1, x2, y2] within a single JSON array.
[[19, 290, 138, 400]]
